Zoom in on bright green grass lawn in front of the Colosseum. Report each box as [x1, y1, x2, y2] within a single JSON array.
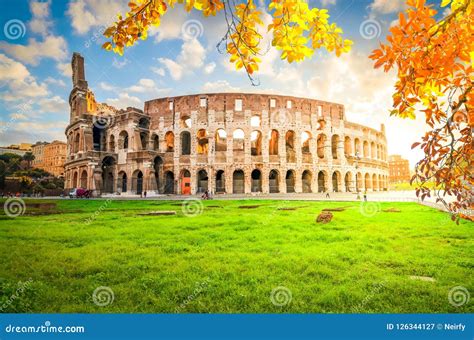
[[0, 200, 474, 313]]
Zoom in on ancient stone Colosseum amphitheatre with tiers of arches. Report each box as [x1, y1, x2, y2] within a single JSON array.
[[65, 53, 388, 195]]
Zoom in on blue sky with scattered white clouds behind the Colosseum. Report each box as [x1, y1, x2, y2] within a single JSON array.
[[0, 0, 448, 165]]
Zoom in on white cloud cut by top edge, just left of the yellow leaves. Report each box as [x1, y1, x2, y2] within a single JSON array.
[[67, 0, 128, 35]]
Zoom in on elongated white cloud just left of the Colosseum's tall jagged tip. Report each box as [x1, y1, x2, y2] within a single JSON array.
[[0, 35, 67, 66]]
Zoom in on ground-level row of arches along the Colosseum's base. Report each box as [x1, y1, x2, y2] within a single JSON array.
[[71, 156, 387, 194]]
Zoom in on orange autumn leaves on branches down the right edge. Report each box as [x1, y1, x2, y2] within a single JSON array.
[[370, 0, 474, 218]]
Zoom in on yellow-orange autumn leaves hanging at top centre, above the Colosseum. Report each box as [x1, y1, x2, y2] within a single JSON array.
[[102, 0, 352, 79]]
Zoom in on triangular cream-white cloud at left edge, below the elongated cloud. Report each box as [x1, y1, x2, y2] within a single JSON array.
[[0, 54, 48, 101]]
